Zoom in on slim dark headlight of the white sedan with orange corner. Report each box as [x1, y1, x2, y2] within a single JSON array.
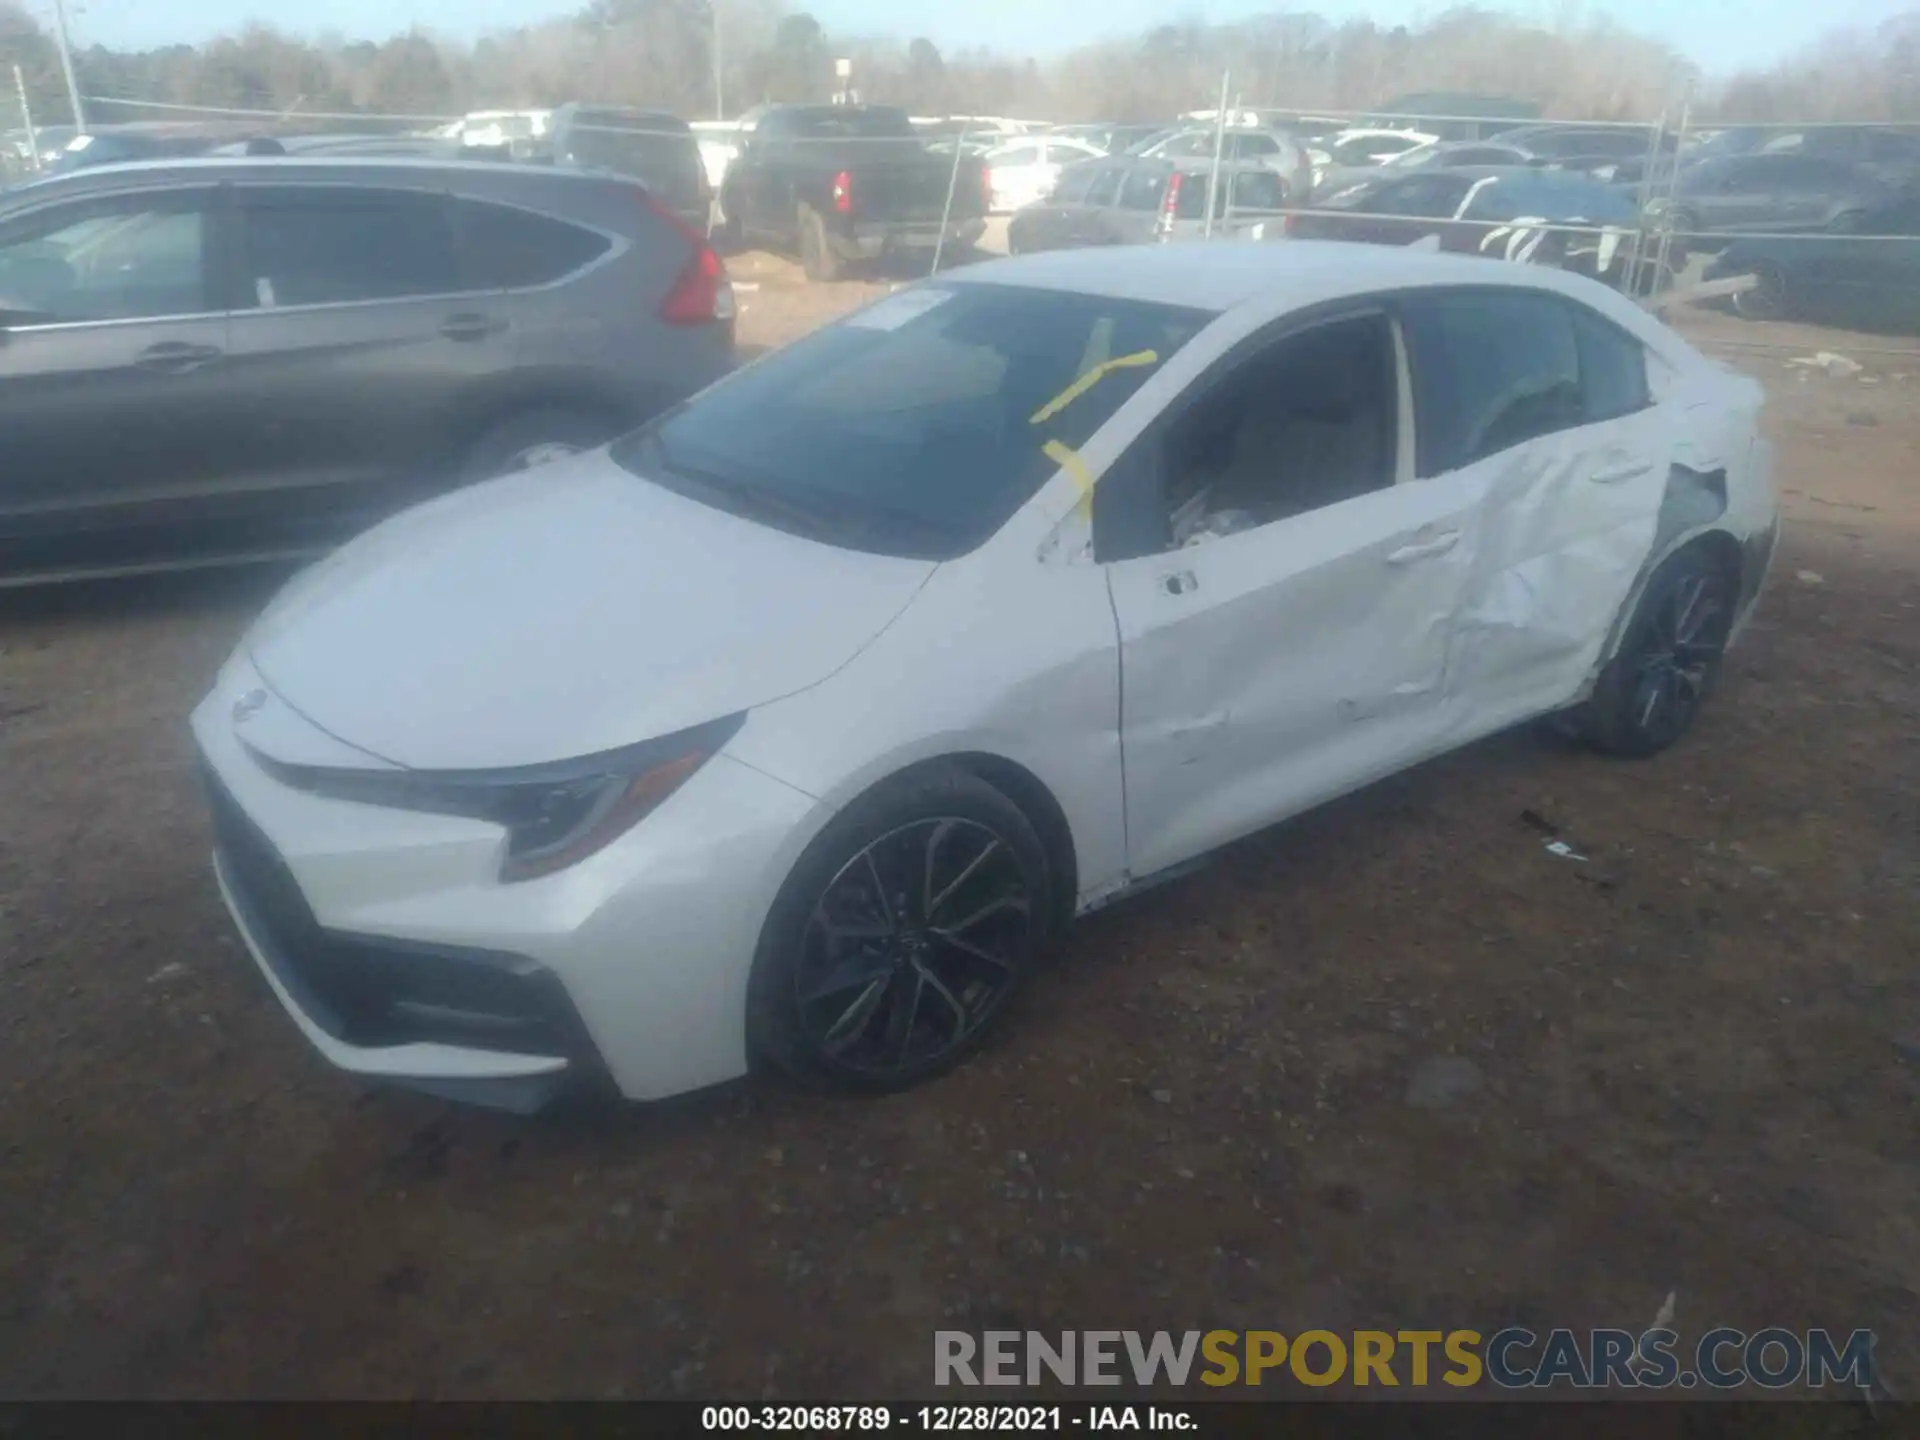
[[255, 712, 747, 881]]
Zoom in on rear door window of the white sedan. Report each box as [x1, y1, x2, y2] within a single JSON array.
[[1404, 290, 1586, 476]]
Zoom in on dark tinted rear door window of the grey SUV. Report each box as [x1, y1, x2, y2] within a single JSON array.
[[238, 186, 463, 309]]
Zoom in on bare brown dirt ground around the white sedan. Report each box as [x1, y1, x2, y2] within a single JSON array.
[[0, 257, 1920, 1400]]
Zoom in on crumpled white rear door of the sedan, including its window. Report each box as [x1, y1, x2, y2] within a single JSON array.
[[1404, 290, 1681, 733]]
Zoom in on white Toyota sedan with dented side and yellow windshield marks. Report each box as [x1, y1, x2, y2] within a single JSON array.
[[194, 242, 1776, 1108]]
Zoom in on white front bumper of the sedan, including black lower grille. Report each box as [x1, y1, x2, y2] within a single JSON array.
[[194, 662, 814, 1112]]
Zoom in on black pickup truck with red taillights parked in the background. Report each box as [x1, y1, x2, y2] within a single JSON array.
[[720, 106, 987, 280]]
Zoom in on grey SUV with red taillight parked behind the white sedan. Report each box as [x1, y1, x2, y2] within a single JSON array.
[[0, 157, 733, 584]]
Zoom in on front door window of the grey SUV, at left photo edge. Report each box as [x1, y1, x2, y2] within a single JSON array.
[[0, 192, 213, 326]]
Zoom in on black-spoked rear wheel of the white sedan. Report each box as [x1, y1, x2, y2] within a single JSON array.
[[1580, 545, 1738, 760]]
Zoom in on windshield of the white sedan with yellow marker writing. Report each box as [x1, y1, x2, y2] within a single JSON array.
[[612, 284, 1212, 559]]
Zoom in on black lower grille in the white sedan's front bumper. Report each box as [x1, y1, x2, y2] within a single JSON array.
[[204, 768, 593, 1062]]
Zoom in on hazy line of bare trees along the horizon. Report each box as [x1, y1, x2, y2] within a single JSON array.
[[0, 0, 1920, 127]]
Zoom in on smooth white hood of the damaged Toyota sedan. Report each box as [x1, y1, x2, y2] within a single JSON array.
[[246, 462, 935, 770]]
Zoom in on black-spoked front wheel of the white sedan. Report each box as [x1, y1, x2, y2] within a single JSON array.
[[747, 764, 1054, 1092]]
